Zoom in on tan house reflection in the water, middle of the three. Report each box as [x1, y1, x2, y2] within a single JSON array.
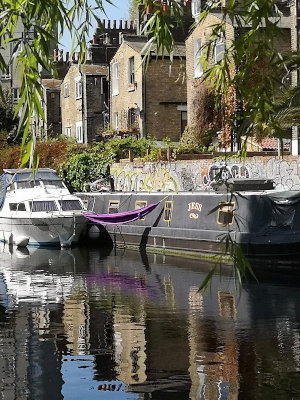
[[114, 308, 147, 385]]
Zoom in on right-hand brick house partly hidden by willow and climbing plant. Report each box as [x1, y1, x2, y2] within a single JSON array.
[[186, 0, 291, 150]]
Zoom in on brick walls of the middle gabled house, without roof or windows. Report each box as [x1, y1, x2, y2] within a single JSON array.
[[111, 42, 186, 140]]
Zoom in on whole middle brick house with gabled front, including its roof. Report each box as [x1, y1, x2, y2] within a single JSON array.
[[110, 36, 186, 141]]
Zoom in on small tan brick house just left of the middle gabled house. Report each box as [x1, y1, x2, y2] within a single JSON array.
[[61, 63, 109, 143]]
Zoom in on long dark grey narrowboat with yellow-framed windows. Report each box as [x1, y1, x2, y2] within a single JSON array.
[[80, 179, 300, 256]]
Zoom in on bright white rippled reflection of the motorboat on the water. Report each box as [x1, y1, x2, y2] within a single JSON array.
[[0, 246, 74, 307]]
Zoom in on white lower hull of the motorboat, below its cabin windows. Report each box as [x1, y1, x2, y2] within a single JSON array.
[[0, 215, 87, 247]]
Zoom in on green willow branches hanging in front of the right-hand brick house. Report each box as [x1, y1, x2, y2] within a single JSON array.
[[143, 0, 299, 142]]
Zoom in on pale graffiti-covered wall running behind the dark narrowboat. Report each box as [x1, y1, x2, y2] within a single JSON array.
[[111, 156, 300, 192]]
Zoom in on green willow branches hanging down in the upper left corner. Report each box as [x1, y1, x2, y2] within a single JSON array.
[[0, 0, 110, 167]]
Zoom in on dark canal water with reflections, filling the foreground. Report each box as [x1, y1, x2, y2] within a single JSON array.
[[0, 246, 300, 400]]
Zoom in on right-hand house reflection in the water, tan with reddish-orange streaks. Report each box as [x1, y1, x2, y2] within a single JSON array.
[[189, 288, 239, 400]]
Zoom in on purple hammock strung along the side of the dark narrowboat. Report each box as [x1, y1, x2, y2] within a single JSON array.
[[83, 202, 160, 225]]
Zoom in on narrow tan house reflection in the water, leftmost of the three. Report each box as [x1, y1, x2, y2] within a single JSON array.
[[63, 286, 90, 355]]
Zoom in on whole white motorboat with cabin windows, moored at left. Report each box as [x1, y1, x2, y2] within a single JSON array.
[[0, 168, 87, 247]]
